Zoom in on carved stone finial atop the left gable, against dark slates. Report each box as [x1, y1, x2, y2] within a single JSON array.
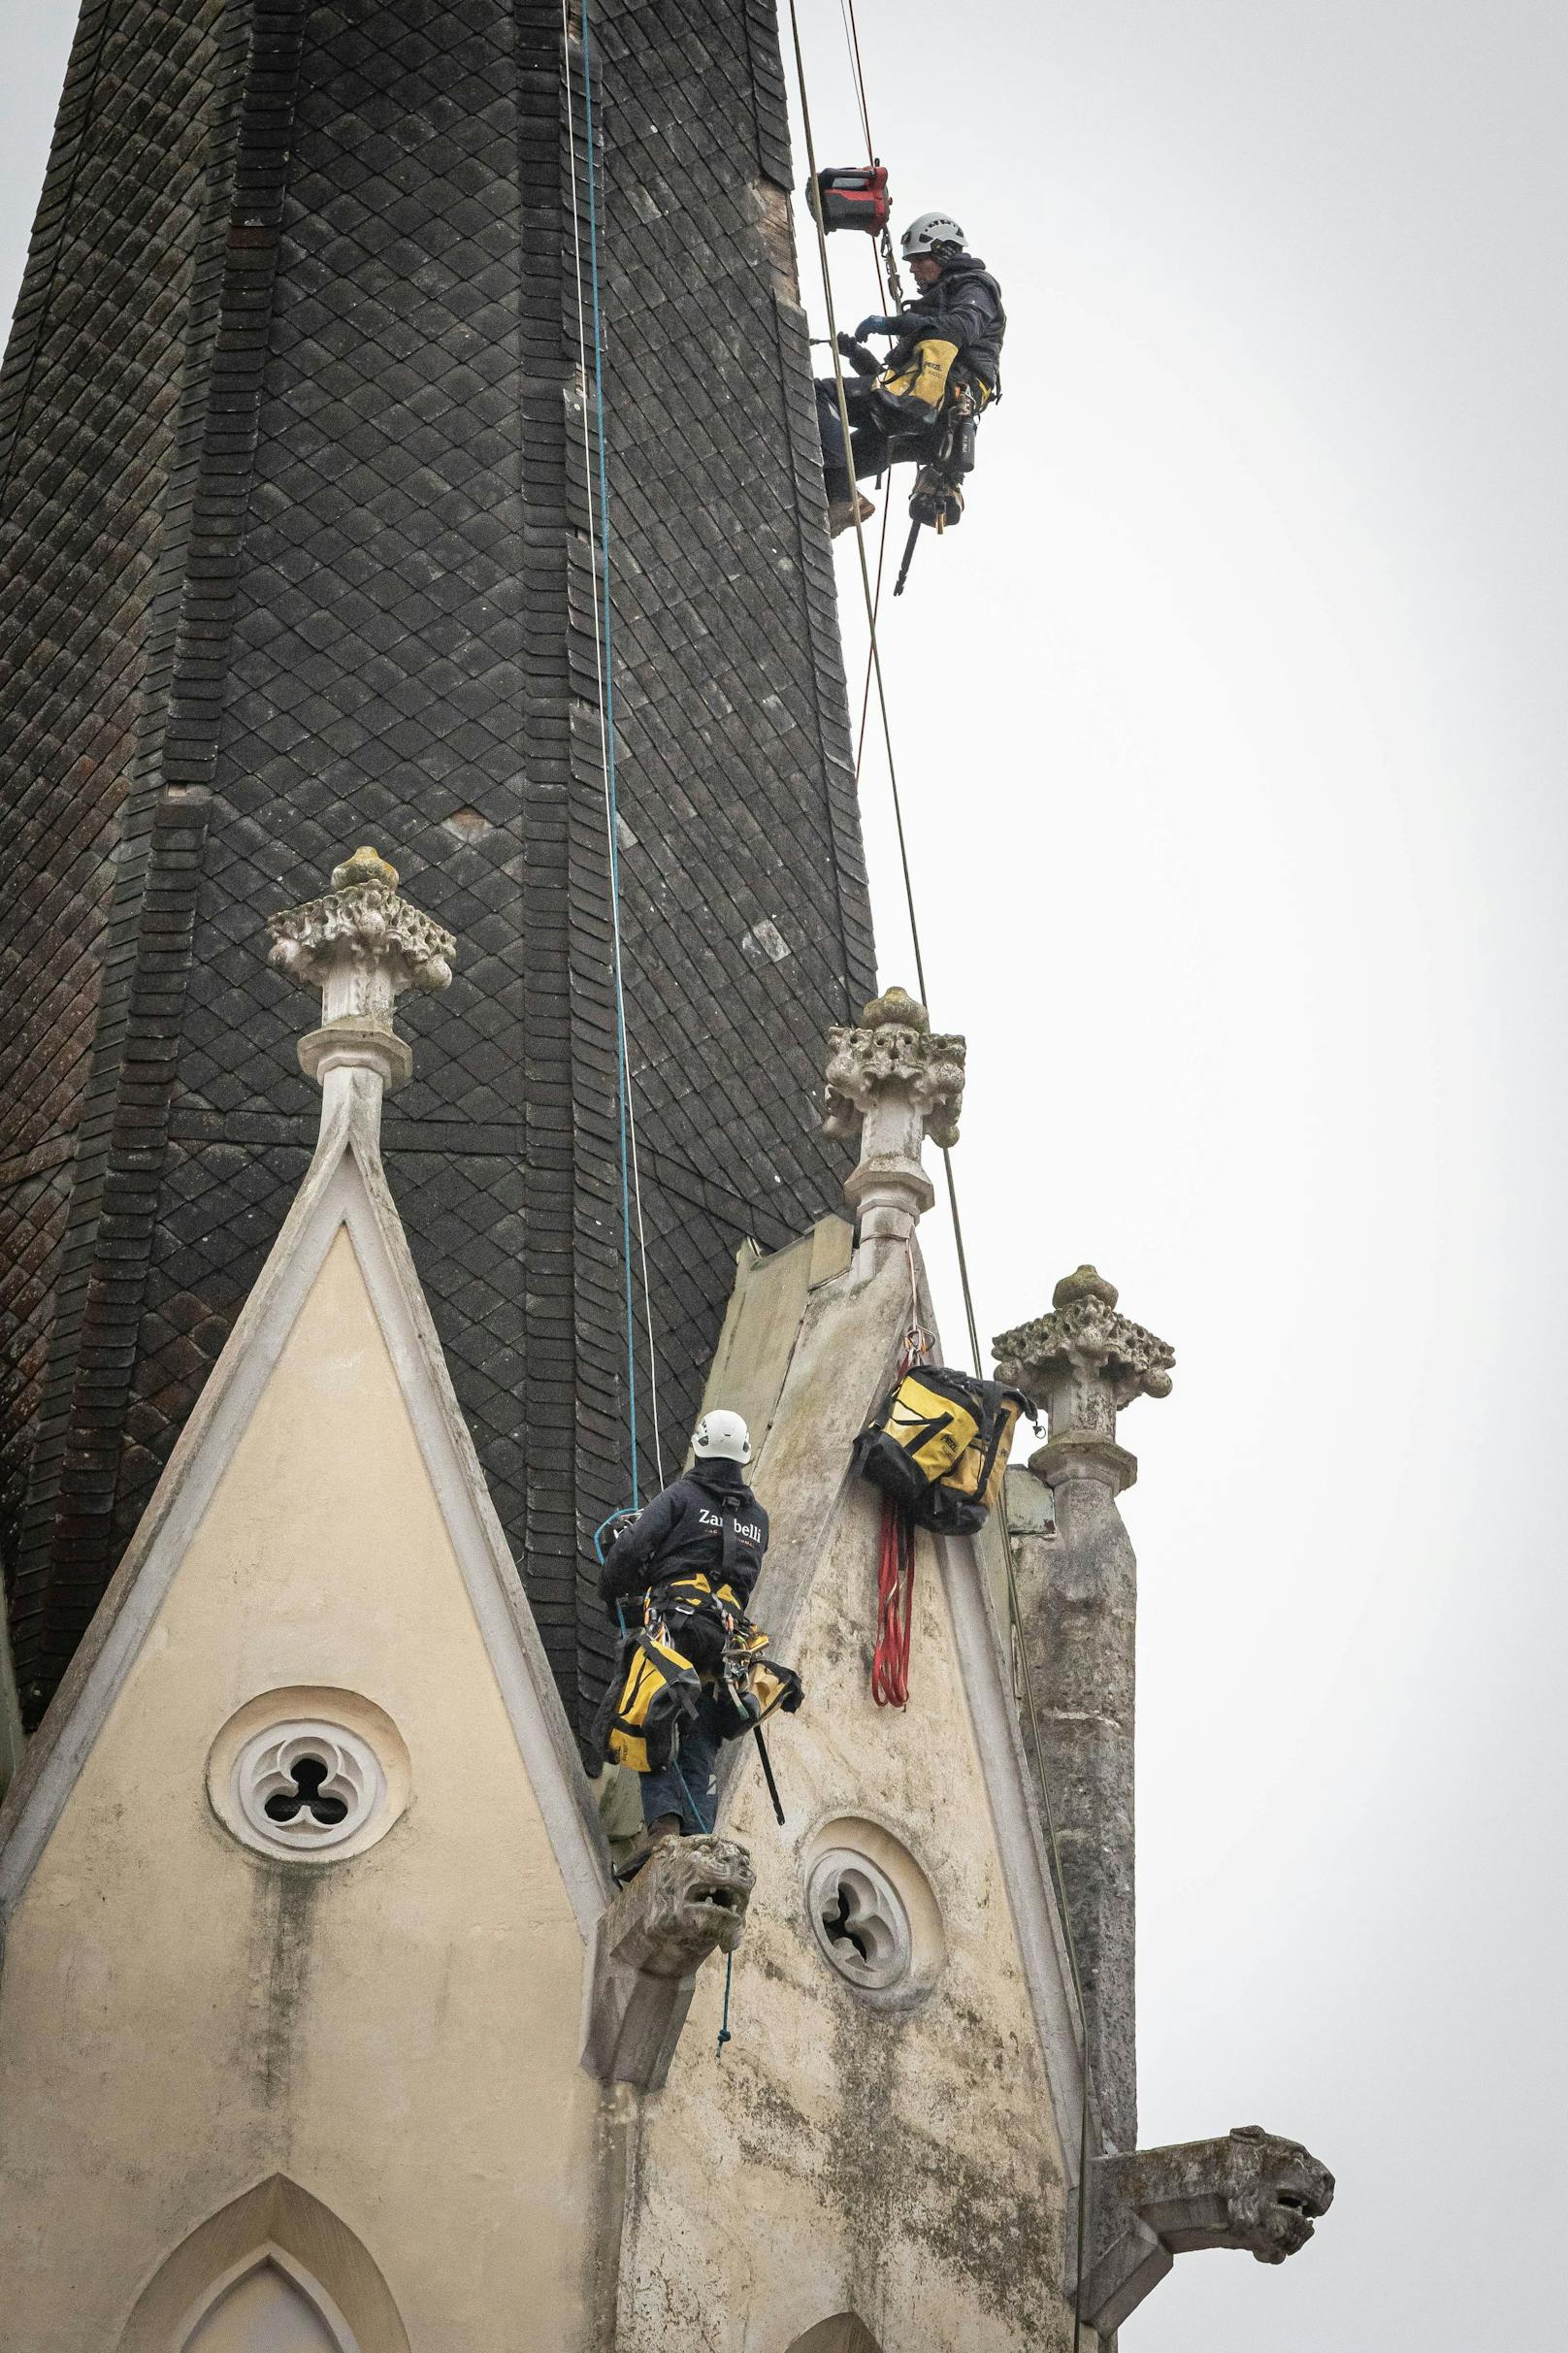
[[269, 849, 457, 1090]]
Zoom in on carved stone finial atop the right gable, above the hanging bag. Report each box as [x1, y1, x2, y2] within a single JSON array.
[[822, 989, 965, 1261]]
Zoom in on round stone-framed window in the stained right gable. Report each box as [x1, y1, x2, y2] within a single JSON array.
[[805, 1816, 946, 2003]]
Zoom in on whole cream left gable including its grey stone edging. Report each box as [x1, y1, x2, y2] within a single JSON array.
[[0, 1129, 603, 2353]]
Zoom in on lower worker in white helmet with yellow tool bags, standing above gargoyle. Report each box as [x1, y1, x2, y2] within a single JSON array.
[[598, 1407, 802, 1880]]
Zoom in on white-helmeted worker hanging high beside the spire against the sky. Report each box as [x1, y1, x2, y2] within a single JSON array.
[[817, 212, 1008, 539]]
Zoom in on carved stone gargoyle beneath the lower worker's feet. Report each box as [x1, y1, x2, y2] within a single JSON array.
[[581, 1838, 756, 2092]]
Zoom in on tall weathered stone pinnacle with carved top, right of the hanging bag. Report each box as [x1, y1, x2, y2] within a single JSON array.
[[996, 1266, 1175, 2148]]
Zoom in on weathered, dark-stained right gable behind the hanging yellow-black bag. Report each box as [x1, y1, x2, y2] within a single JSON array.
[[622, 1266, 1083, 2353]]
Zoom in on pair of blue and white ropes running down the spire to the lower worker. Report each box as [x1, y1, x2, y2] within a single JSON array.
[[560, 0, 664, 1501]]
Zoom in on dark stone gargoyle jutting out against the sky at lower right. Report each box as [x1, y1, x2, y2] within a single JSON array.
[[1078, 2125, 1335, 2337]]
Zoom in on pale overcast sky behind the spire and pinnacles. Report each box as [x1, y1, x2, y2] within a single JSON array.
[[0, 0, 1568, 2353]]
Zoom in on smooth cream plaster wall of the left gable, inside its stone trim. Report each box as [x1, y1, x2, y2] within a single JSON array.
[[0, 1230, 603, 2353]]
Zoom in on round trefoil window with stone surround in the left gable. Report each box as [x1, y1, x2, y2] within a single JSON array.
[[208, 1684, 409, 1861]]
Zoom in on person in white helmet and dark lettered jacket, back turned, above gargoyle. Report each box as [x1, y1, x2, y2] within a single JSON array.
[[598, 1407, 799, 1878]]
